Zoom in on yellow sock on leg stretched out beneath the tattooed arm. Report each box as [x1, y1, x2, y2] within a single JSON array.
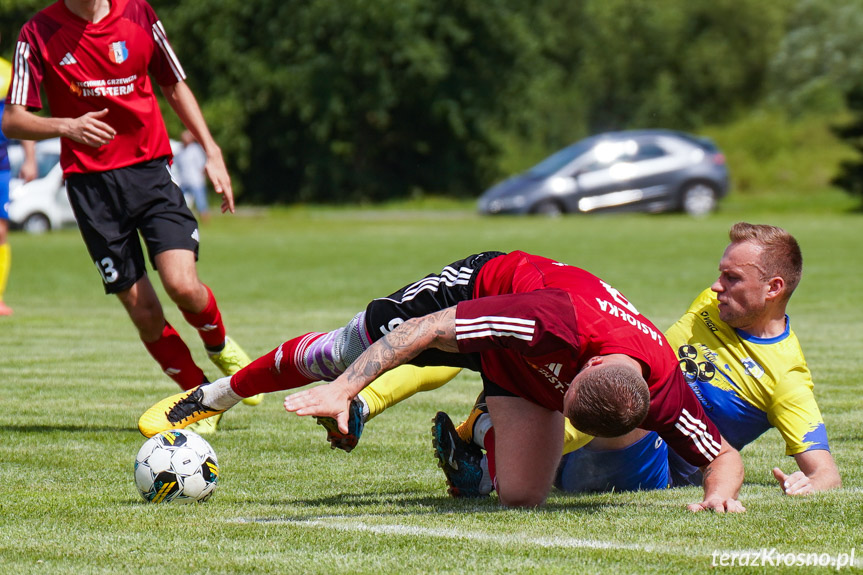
[[360, 365, 461, 421]]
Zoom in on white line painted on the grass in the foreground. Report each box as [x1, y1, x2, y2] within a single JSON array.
[[232, 517, 654, 552]]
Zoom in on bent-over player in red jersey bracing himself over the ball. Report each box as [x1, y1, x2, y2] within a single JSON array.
[[139, 252, 743, 511]]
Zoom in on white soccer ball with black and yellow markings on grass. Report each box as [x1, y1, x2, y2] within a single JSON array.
[[135, 429, 219, 503]]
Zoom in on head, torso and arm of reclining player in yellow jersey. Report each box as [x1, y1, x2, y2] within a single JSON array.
[[666, 223, 841, 495]]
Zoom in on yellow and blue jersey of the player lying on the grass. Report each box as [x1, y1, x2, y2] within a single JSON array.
[[665, 289, 829, 455]]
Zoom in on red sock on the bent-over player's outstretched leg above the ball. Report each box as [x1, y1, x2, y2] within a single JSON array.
[[231, 333, 324, 397]]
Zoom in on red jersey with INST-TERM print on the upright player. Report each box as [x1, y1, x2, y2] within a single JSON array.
[[6, 0, 185, 174]]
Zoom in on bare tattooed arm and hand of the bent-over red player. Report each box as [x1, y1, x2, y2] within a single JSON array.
[[285, 307, 458, 433]]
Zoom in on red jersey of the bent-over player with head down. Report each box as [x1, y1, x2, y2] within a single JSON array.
[[456, 252, 721, 467]]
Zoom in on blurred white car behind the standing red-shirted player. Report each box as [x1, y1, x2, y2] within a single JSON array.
[[9, 138, 75, 234]]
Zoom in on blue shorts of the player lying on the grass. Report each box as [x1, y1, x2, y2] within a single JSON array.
[[554, 431, 670, 493]]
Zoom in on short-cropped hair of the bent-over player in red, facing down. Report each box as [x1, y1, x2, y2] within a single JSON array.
[[564, 365, 650, 437]]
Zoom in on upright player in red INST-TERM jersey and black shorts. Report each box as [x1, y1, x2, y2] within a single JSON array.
[[2, 0, 262, 431]]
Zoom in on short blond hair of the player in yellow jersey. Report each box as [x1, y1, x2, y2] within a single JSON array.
[[728, 222, 803, 301]]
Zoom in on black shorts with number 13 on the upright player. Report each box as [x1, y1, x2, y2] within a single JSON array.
[[66, 158, 198, 294]]
